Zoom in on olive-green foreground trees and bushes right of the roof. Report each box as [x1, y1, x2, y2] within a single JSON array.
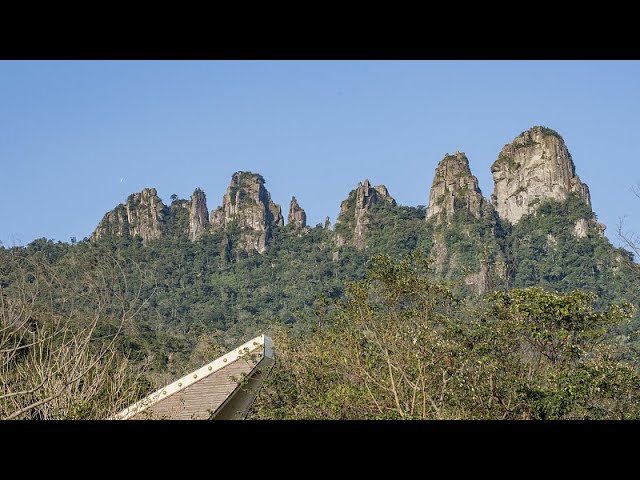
[[252, 256, 640, 419]]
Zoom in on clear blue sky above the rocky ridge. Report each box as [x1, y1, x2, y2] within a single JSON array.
[[0, 61, 640, 246]]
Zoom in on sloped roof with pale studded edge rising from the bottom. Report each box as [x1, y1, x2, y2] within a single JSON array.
[[113, 335, 274, 420]]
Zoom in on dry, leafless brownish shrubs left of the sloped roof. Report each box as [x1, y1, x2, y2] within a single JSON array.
[[0, 249, 149, 420]]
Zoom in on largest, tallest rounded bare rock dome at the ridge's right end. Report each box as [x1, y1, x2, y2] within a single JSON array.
[[491, 127, 591, 224]]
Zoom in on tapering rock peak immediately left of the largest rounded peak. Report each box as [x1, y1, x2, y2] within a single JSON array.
[[427, 152, 491, 222]]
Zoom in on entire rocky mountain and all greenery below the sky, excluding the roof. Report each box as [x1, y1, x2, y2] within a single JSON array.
[[0, 127, 640, 418]]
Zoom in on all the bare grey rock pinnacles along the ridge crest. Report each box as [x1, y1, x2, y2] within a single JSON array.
[[91, 126, 606, 253]]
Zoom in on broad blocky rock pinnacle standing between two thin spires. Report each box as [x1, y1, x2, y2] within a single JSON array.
[[210, 172, 284, 253]]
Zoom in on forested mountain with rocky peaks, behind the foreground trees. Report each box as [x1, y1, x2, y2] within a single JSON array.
[[0, 127, 640, 410]]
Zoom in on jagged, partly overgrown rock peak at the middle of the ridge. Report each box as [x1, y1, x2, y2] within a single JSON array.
[[336, 180, 396, 248]]
